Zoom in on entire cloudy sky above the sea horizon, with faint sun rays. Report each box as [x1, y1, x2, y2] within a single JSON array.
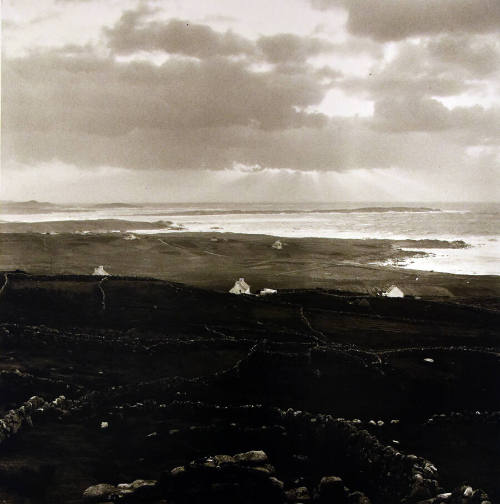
[[0, 0, 500, 202]]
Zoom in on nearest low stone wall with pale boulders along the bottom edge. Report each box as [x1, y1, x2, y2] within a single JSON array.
[[82, 444, 491, 504]]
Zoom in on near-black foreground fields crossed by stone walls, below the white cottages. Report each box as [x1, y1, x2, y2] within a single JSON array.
[[0, 273, 500, 504]]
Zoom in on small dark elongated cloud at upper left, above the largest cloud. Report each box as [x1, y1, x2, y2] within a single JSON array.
[[105, 8, 254, 58]]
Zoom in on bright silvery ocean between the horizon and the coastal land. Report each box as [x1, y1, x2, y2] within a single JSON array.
[[1, 202, 500, 275]]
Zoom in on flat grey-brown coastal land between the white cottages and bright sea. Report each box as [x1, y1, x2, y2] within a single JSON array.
[[0, 228, 500, 302]]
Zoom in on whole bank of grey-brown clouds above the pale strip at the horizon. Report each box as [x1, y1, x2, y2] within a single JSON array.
[[2, 0, 500, 198]]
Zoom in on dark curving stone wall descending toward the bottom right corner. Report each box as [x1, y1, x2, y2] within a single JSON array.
[[70, 401, 487, 504]]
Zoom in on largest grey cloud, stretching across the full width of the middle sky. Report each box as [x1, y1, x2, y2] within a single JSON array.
[[2, 39, 498, 171]]
